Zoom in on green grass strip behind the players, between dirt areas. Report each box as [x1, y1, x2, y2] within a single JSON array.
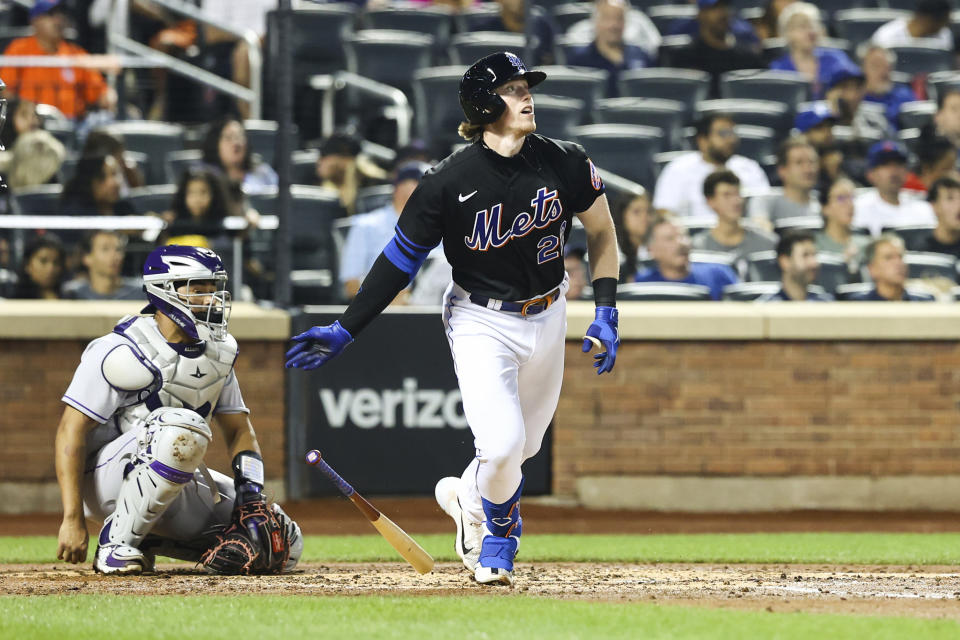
[[0, 533, 960, 565]]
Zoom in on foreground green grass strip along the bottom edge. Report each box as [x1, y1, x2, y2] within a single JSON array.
[[0, 595, 960, 640]]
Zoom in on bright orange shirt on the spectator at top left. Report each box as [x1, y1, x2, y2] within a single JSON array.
[[0, 36, 107, 118]]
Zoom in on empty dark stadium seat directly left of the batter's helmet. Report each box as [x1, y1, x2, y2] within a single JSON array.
[[413, 66, 468, 143]]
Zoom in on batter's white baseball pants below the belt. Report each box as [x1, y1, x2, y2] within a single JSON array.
[[443, 279, 568, 522]]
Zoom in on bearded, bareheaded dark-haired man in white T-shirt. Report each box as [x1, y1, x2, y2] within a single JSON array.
[[653, 113, 770, 218]]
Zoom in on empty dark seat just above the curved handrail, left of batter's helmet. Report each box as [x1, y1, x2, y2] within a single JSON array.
[[343, 29, 434, 93]]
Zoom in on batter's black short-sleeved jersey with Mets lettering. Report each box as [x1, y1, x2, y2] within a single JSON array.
[[397, 134, 604, 301]]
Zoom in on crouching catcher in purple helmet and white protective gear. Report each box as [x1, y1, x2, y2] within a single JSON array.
[[56, 245, 303, 574]]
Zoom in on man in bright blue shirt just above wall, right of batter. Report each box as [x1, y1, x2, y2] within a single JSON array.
[[636, 215, 739, 300]]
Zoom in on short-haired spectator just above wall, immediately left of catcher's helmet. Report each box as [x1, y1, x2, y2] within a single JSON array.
[[63, 229, 143, 300]]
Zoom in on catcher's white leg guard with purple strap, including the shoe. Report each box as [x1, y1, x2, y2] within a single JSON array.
[[94, 407, 213, 573]]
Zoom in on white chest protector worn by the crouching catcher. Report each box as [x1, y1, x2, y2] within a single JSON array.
[[107, 316, 237, 433]]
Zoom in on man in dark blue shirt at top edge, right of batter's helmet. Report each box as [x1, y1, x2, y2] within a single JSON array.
[[567, 0, 650, 98]]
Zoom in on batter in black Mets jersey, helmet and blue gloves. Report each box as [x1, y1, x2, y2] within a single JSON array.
[[287, 52, 619, 584]]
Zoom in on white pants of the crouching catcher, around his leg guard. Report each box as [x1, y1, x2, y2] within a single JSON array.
[[83, 429, 235, 541]]
